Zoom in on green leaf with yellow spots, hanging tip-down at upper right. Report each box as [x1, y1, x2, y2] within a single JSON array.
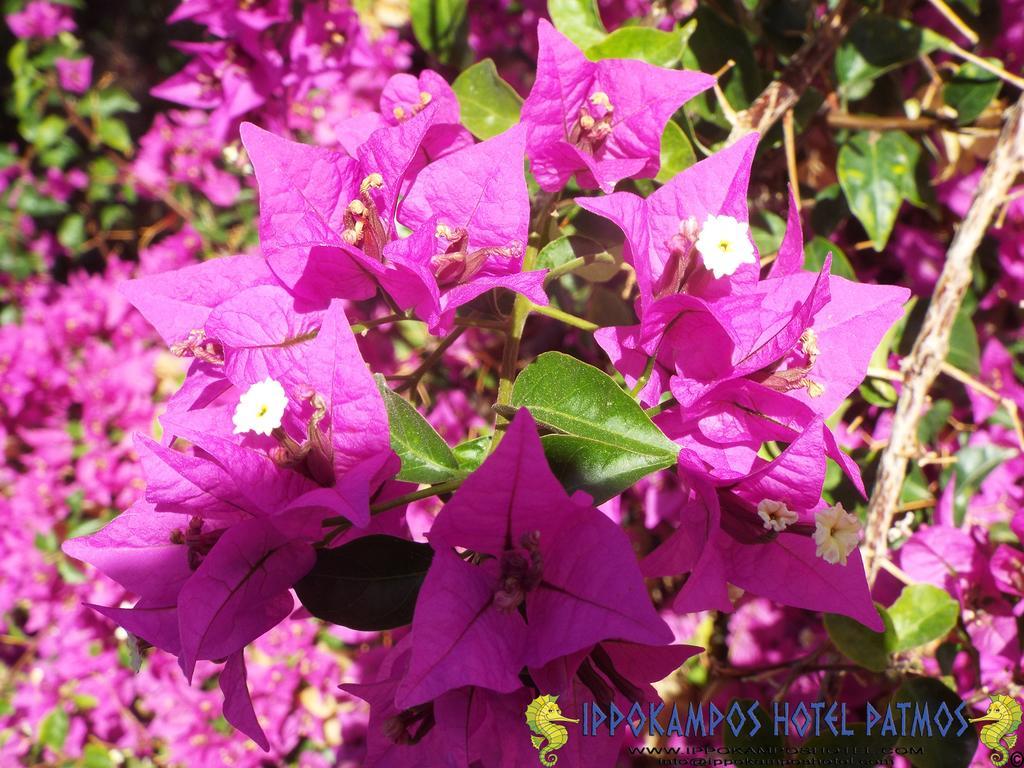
[[837, 131, 921, 251]]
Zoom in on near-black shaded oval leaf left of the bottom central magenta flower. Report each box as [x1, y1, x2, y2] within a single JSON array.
[[295, 535, 434, 632]]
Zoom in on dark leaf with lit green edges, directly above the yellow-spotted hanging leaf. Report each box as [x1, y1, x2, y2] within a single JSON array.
[[836, 13, 948, 100]]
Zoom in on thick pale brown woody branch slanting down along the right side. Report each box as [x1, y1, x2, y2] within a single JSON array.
[[864, 96, 1024, 584]]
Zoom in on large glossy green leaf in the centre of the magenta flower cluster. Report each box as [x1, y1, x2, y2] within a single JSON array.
[[511, 352, 679, 504]]
